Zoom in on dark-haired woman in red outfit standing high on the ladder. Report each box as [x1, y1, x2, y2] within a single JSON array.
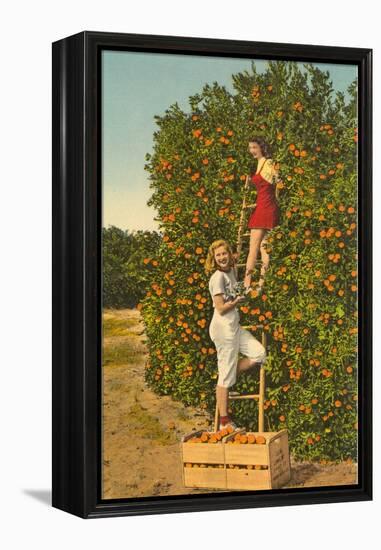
[[244, 137, 280, 292]]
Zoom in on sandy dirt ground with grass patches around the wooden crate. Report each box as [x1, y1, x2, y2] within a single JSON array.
[[103, 309, 357, 499]]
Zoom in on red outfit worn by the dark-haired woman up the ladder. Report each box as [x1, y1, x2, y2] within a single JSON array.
[[247, 161, 279, 229]]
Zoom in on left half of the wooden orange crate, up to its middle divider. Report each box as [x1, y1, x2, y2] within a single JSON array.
[[181, 430, 226, 489]]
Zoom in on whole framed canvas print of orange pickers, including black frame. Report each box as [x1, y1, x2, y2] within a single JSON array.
[[52, 31, 372, 518]]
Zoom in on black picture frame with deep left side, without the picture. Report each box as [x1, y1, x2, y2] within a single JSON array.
[[52, 31, 373, 518]]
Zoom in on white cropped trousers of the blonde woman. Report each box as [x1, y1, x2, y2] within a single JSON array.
[[211, 326, 266, 388]]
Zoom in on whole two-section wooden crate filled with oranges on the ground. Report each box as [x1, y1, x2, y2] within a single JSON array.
[[181, 429, 291, 491]]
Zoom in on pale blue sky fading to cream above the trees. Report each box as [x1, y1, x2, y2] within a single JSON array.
[[102, 50, 357, 231]]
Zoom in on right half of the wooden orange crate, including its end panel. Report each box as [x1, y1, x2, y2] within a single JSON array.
[[224, 429, 291, 491]]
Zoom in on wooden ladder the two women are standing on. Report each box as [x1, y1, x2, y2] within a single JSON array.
[[214, 175, 267, 432]]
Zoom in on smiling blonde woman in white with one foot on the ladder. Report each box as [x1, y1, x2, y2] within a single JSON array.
[[205, 239, 266, 430]]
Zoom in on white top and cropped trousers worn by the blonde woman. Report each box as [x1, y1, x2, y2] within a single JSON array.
[[209, 268, 266, 388]]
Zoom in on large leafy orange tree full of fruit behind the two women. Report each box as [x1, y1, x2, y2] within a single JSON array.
[[138, 61, 357, 462]]
